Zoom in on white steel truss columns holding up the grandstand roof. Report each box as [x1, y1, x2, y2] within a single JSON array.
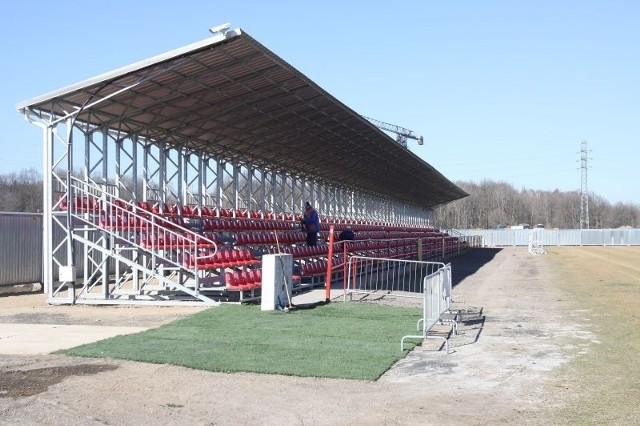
[[22, 106, 430, 304]]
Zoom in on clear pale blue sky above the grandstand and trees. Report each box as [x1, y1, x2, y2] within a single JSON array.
[[0, 0, 640, 204]]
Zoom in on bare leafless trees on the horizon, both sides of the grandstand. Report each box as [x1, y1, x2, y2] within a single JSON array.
[[0, 169, 640, 229]]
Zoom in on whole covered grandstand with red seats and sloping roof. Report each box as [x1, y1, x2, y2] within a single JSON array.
[[17, 29, 468, 305]]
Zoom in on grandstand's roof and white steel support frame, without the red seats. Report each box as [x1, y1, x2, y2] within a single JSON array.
[[17, 25, 467, 303]]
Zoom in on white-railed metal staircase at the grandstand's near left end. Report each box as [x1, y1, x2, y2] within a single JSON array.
[[57, 178, 224, 305]]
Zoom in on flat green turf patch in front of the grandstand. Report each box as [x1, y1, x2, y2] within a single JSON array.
[[58, 302, 421, 380]]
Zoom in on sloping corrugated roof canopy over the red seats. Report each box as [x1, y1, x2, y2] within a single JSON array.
[[17, 29, 467, 208]]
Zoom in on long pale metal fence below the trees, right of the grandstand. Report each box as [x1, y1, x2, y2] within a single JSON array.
[[456, 228, 640, 247]]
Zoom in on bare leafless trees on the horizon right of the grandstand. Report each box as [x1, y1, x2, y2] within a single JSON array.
[[433, 180, 640, 229]]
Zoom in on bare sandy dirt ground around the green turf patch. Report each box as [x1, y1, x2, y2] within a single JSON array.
[[0, 247, 640, 425]]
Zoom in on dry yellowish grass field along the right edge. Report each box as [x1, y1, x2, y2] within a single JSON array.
[[541, 247, 640, 424]]
